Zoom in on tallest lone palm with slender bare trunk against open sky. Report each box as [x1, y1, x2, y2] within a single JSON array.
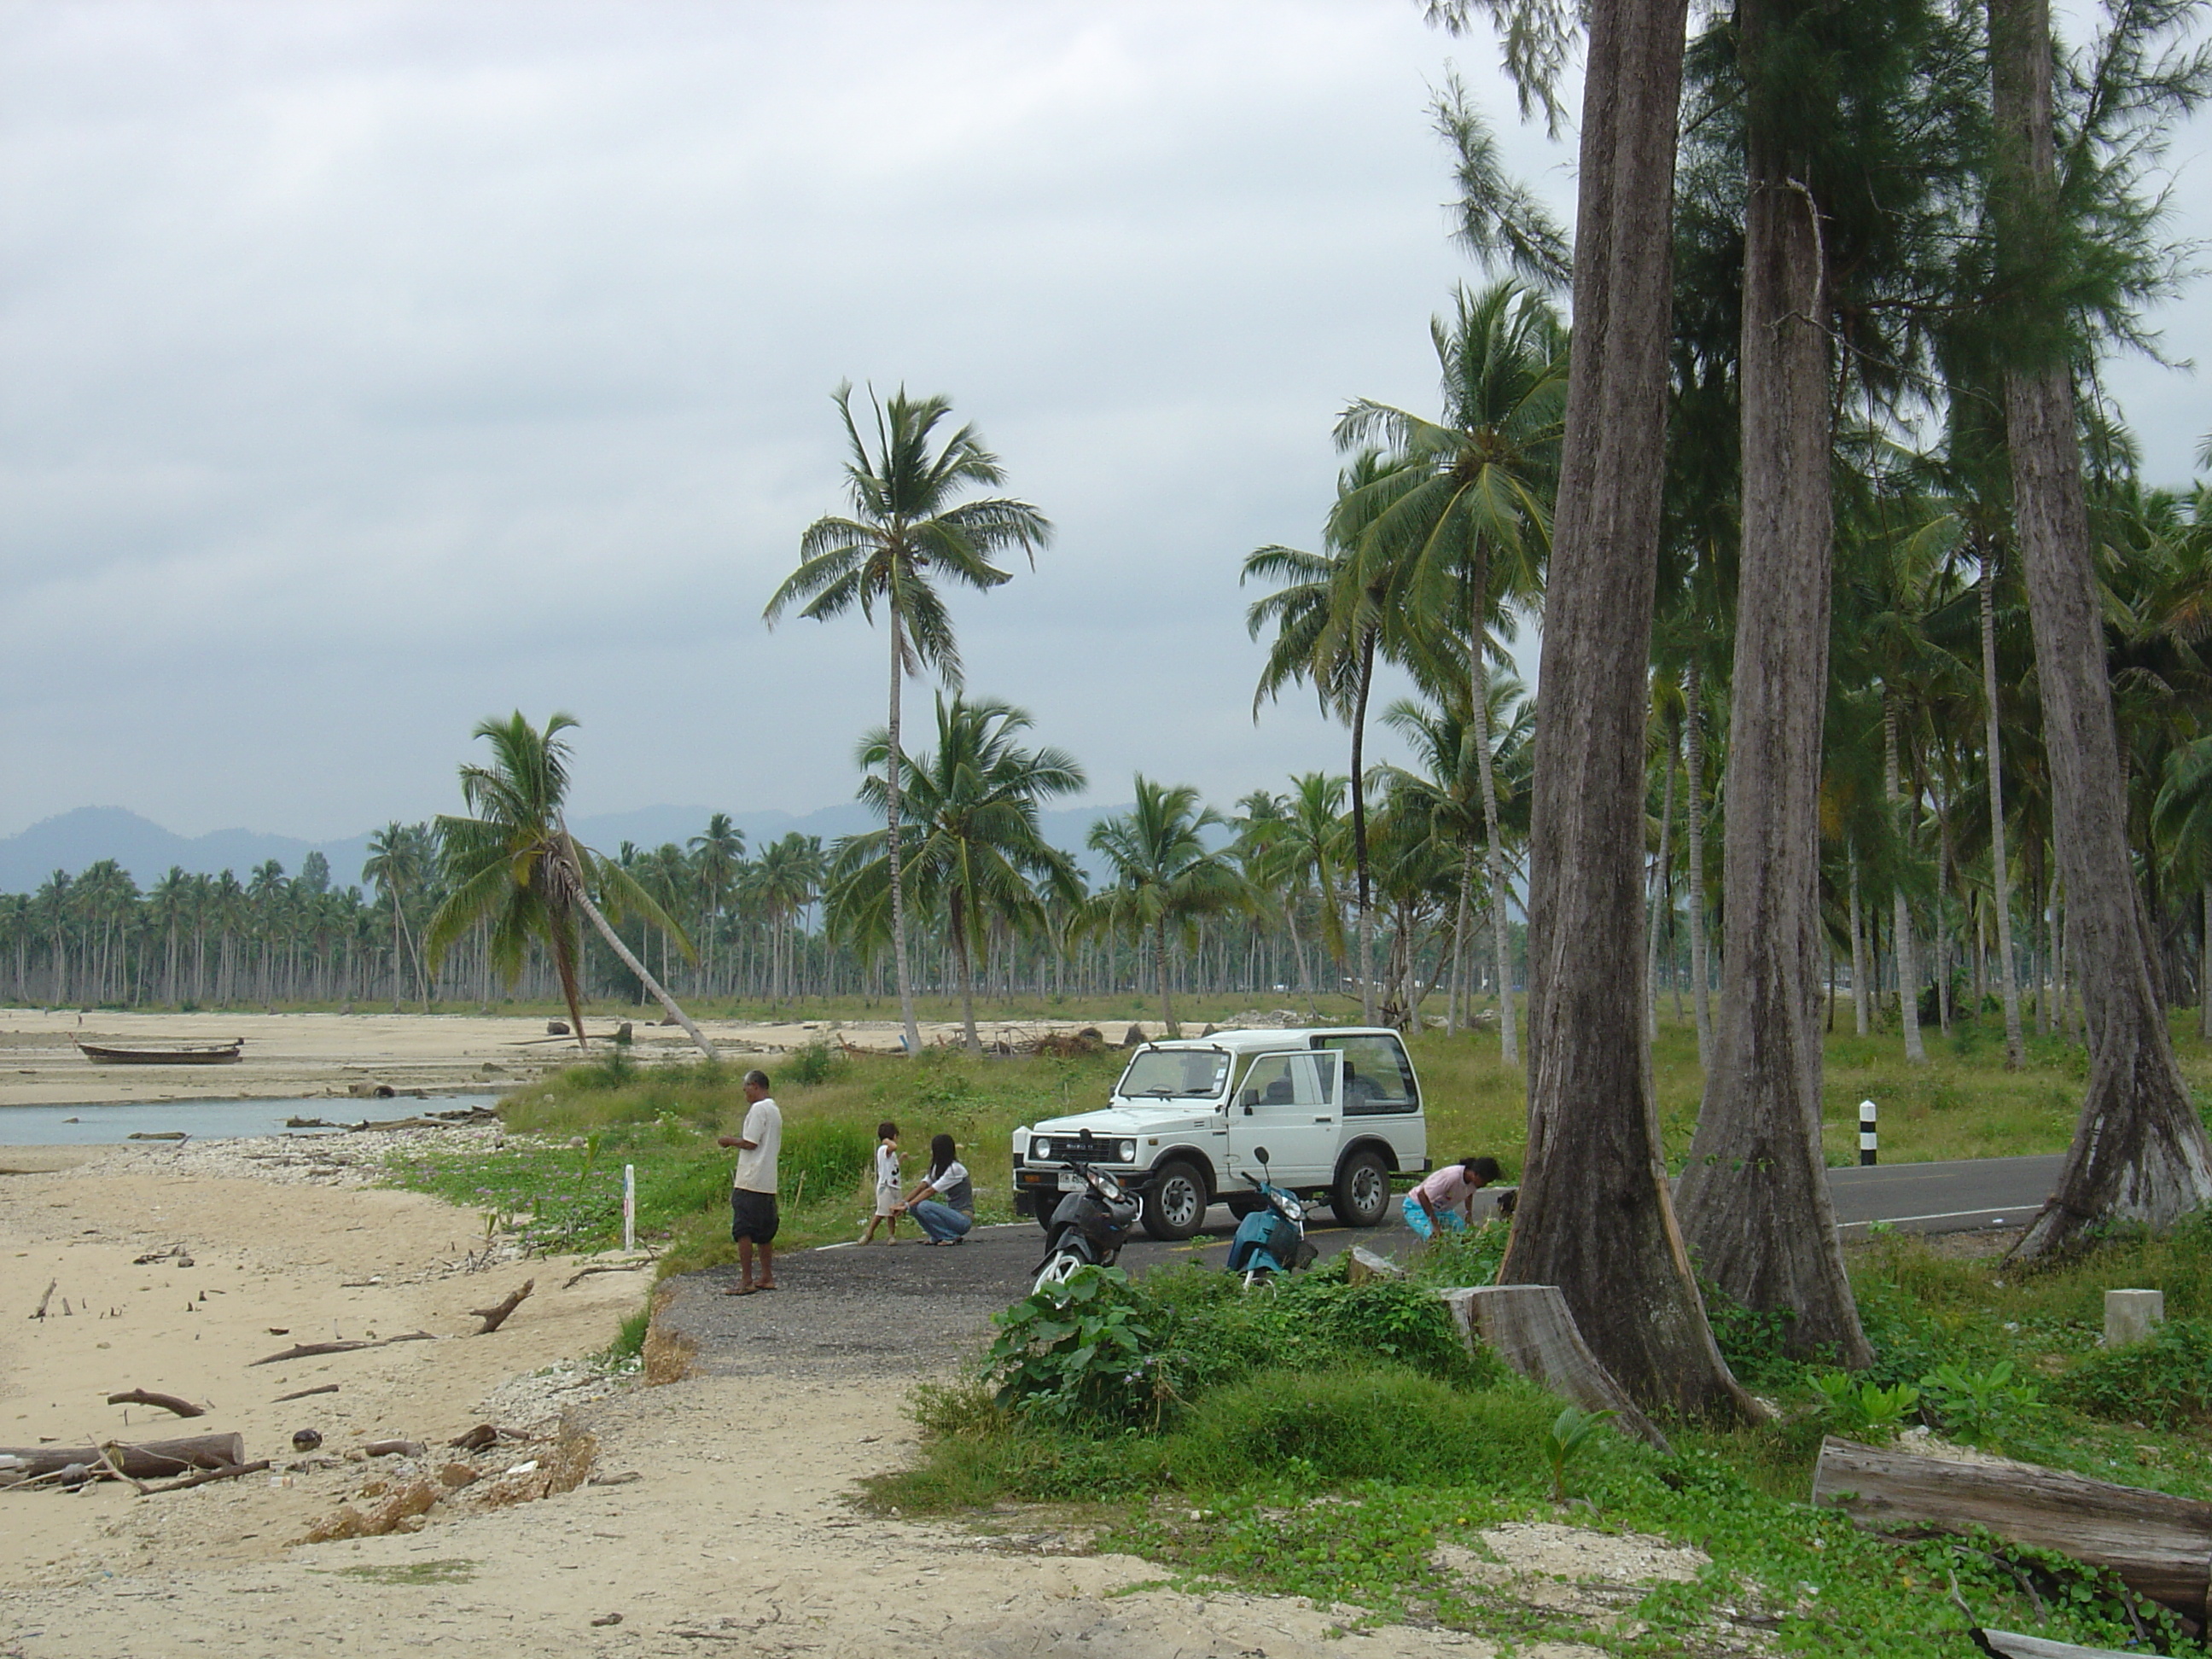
[[763, 382, 1053, 1055]]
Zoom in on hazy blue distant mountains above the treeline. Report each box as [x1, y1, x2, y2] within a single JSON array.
[[0, 800, 1126, 894]]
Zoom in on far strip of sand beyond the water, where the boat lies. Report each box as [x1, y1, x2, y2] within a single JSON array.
[[0, 1009, 1120, 1106]]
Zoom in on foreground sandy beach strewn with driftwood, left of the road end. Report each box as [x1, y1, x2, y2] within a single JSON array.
[[0, 1131, 1595, 1659]]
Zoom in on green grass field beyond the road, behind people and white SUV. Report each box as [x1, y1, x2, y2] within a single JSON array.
[[375, 998, 2212, 1272]]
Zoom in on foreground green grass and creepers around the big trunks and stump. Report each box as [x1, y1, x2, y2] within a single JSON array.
[[870, 1225, 2212, 1656]]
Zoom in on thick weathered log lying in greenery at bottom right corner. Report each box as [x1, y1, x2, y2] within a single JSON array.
[[1812, 1435, 2212, 1624]]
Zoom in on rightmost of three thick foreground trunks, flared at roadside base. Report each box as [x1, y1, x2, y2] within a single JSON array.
[[1988, 0, 2212, 1259]]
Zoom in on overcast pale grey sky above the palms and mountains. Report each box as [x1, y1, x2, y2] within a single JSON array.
[[0, 0, 2212, 838]]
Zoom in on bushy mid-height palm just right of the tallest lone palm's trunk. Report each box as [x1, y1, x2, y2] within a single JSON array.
[[830, 695, 1086, 1055]]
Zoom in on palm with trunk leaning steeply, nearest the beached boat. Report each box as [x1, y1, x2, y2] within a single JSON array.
[[427, 710, 721, 1060]]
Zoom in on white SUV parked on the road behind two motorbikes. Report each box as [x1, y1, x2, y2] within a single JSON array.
[[1013, 1027, 1429, 1239]]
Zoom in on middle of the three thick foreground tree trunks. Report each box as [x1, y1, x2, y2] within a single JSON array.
[[1674, 65, 1873, 1369]]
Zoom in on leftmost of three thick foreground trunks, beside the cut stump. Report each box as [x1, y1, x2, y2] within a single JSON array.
[[1499, 0, 1756, 1416]]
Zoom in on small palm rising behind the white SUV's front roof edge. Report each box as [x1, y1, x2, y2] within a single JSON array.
[[1091, 772, 1249, 1038]]
